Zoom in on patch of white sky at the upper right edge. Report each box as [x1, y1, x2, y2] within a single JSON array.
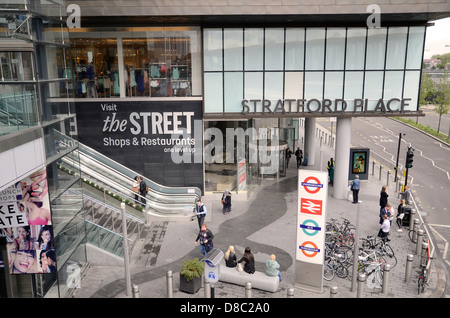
[[424, 18, 450, 59]]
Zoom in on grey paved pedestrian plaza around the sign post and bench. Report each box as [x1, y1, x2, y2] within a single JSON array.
[[73, 149, 446, 298]]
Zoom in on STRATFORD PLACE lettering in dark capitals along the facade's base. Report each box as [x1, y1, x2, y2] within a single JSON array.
[[241, 98, 417, 115]]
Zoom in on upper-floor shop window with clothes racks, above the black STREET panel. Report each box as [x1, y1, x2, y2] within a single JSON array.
[[70, 27, 201, 98]]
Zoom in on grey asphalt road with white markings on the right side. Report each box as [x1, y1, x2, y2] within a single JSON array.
[[317, 110, 450, 295]]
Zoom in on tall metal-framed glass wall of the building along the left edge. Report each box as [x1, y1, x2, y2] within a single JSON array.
[[0, 0, 86, 298]]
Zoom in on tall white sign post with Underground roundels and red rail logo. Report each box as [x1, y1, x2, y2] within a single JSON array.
[[294, 170, 328, 292]]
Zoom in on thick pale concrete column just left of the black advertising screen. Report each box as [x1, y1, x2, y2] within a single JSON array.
[[334, 118, 352, 200]]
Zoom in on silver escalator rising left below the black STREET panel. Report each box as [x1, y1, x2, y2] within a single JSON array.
[[55, 131, 201, 222]]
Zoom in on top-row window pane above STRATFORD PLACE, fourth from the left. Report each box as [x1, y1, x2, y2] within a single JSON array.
[[265, 28, 284, 71]]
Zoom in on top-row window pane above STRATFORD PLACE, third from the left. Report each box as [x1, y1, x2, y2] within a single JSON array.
[[244, 29, 264, 71]]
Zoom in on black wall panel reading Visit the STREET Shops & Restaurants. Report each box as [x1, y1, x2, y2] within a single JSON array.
[[76, 100, 203, 191]]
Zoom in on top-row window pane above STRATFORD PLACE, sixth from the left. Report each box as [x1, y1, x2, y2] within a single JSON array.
[[305, 28, 325, 70]]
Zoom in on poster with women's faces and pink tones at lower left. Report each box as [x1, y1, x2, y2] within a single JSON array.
[[0, 169, 56, 274]]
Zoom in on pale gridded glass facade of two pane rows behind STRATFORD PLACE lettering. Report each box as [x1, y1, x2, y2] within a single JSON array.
[[203, 26, 425, 117]]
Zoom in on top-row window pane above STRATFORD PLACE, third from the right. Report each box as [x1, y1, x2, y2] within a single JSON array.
[[366, 29, 386, 70]]
